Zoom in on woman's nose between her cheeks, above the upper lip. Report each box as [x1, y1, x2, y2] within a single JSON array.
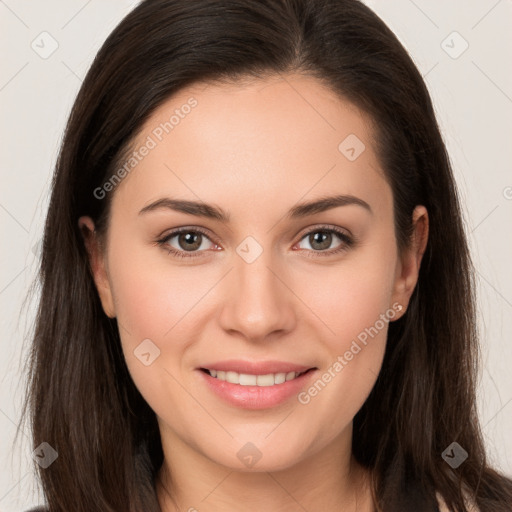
[[220, 245, 300, 342]]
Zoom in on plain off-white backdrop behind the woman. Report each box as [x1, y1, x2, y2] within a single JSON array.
[[0, 0, 512, 512]]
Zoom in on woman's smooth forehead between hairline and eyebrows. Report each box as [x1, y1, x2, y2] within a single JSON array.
[[114, 75, 390, 222]]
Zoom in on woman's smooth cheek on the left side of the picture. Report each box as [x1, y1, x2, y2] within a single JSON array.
[[106, 246, 204, 424]]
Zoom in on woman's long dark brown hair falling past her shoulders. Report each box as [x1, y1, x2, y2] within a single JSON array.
[[18, 0, 512, 512]]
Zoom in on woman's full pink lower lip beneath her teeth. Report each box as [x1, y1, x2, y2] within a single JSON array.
[[197, 370, 316, 409]]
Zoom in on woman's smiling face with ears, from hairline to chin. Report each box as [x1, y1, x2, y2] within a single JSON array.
[[80, 75, 426, 470]]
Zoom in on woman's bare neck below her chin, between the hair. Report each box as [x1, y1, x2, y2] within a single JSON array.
[[157, 426, 374, 512]]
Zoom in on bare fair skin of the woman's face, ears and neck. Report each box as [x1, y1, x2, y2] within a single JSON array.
[[79, 74, 428, 512]]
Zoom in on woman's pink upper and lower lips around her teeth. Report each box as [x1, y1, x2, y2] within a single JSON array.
[[196, 361, 318, 410]]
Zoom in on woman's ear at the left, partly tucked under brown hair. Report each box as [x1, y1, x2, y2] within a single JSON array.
[[78, 217, 116, 318]]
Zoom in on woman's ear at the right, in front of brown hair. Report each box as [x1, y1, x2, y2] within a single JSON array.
[[391, 205, 429, 319]]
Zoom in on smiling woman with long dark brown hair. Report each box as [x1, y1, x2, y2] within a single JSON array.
[[18, 0, 512, 512]]
